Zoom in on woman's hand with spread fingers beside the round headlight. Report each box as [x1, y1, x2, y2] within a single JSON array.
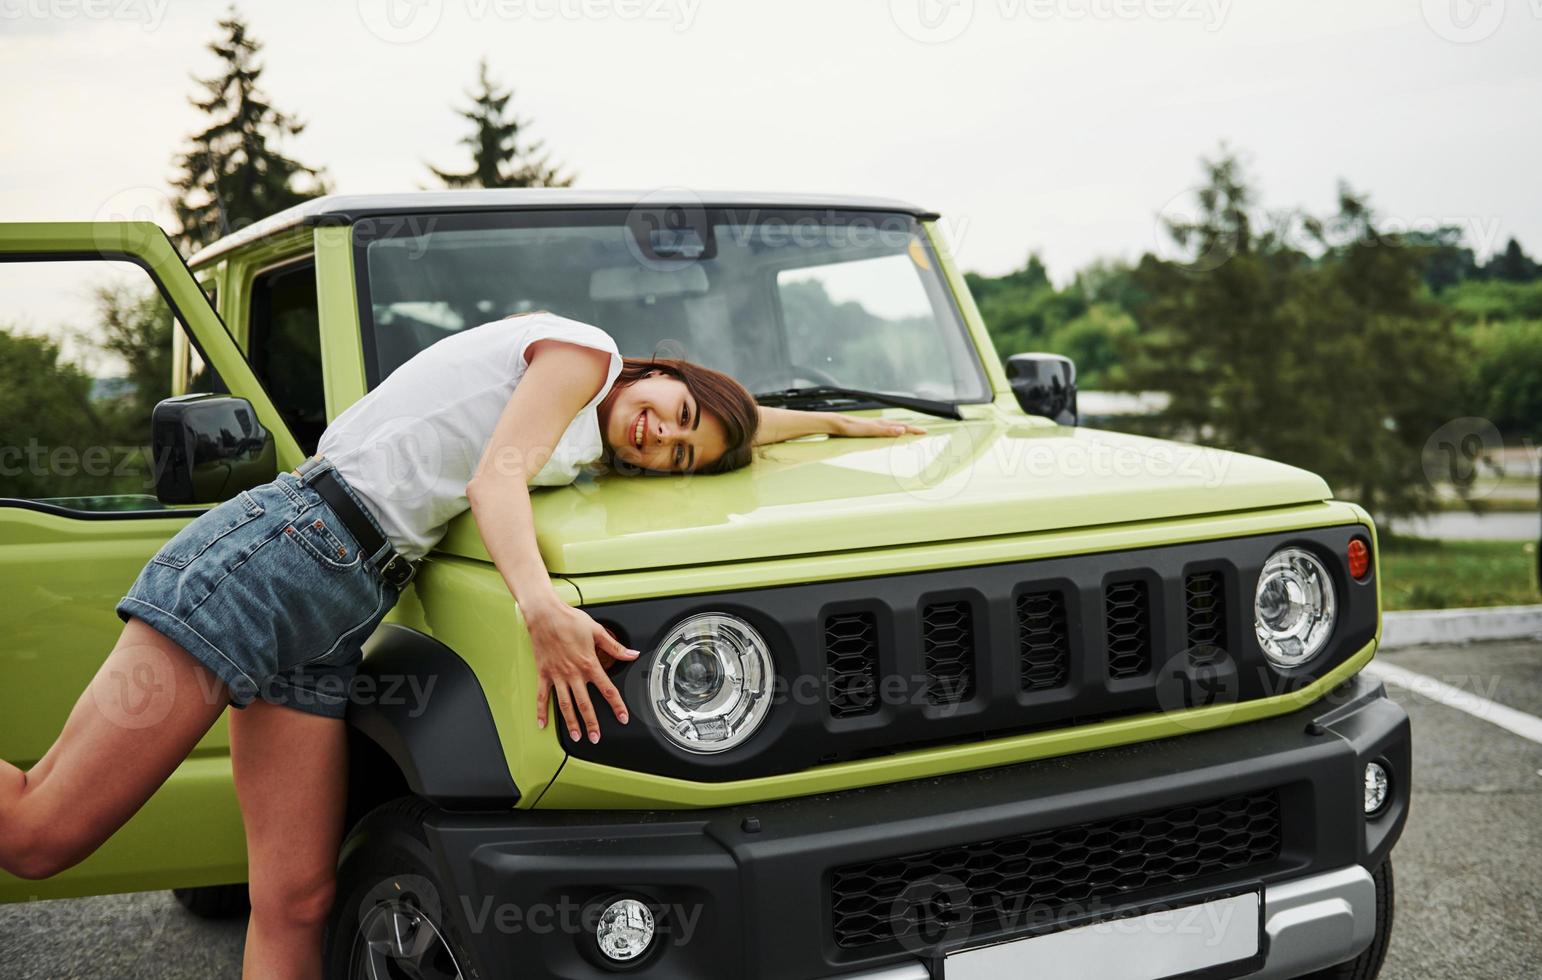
[[524, 595, 638, 743]]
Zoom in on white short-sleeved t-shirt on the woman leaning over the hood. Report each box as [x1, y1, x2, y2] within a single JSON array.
[[316, 313, 621, 559]]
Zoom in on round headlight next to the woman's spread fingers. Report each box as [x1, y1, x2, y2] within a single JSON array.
[[648, 613, 773, 753]]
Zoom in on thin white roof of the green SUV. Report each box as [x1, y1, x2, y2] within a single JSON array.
[[188, 188, 938, 265]]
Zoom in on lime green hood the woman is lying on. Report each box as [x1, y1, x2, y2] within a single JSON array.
[[439, 416, 1331, 575]]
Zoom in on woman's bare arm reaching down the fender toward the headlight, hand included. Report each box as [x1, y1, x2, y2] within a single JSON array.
[[466, 341, 638, 741]]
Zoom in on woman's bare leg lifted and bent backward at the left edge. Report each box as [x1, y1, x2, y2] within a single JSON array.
[[0, 618, 230, 878]]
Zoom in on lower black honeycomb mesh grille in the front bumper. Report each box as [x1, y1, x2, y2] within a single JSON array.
[[830, 790, 1283, 949]]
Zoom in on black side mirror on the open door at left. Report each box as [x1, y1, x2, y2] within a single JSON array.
[[150, 394, 278, 504]]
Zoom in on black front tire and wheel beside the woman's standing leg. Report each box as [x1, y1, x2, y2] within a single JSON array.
[[322, 797, 481, 980]]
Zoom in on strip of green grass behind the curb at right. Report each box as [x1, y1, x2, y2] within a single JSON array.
[[1380, 535, 1542, 610]]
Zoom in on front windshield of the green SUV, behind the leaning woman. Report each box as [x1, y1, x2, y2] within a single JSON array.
[[355, 206, 988, 402]]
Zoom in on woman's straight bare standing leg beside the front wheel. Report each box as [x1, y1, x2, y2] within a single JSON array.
[[230, 700, 348, 980]]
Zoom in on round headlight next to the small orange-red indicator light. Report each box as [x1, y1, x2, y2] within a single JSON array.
[[1254, 549, 1338, 667]]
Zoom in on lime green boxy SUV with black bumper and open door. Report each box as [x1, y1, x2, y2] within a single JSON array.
[[0, 190, 1409, 980]]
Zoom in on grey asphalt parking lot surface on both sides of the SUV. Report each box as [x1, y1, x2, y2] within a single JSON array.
[[0, 643, 1542, 980]]
